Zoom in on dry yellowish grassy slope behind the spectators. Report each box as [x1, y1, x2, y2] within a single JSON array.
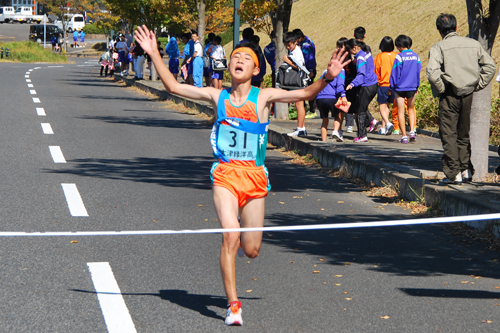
[[226, 0, 500, 96]]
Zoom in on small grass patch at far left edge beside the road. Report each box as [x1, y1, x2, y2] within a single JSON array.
[[0, 41, 68, 63]]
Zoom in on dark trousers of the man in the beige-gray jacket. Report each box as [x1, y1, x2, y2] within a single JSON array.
[[439, 89, 474, 180]]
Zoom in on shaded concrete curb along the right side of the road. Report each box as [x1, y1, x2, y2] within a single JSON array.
[[114, 74, 500, 237]]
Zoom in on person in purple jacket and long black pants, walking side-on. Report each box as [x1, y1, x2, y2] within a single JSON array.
[[346, 38, 378, 142]]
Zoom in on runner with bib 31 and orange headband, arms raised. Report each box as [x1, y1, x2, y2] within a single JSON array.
[[135, 26, 347, 325]]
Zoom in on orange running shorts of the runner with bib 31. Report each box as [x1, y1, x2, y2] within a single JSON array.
[[210, 162, 271, 207]]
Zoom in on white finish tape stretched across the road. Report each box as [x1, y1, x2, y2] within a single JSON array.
[[0, 213, 500, 237]]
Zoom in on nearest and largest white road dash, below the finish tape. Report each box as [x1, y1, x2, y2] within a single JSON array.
[[87, 262, 137, 333]]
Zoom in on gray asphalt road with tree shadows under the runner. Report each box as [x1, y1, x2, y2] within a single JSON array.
[[0, 59, 500, 332]]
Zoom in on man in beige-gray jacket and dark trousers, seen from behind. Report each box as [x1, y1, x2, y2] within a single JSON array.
[[427, 14, 496, 184]]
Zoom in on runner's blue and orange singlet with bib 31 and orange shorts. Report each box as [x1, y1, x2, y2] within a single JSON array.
[[210, 87, 270, 207]]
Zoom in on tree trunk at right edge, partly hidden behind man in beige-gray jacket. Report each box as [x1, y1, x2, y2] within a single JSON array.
[[466, 0, 500, 180]]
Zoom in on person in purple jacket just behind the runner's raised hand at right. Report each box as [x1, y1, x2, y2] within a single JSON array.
[[316, 69, 348, 142]]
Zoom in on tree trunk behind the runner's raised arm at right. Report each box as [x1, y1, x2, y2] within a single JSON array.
[[272, 0, 293, 119]]
